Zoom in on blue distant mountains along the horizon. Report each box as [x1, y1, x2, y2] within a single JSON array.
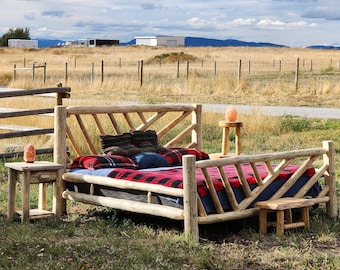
[[38, 37, 340, 50]]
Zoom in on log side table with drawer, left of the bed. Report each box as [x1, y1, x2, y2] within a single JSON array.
[[5, 161, 64, 222]]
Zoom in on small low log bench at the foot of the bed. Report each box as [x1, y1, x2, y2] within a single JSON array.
[[255, 198, 314, 236]]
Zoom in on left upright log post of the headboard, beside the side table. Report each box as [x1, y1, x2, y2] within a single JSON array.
[[53, 106, 67, 214]]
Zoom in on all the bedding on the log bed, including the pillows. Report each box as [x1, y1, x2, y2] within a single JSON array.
[[67, 130, 321, 213]]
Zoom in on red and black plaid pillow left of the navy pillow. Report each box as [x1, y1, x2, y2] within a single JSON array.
[[71, 155, 138, 170]]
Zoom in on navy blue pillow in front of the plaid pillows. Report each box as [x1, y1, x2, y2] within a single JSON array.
[[131, 152, 169, 169]]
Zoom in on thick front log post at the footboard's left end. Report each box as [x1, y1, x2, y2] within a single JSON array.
[[183, 155, 199, 242]]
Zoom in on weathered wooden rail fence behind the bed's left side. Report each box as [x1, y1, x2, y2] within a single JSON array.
[[0, 87, 71, 158]]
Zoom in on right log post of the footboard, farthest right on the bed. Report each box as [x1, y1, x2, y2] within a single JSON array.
[[322, 141, 338, 218]]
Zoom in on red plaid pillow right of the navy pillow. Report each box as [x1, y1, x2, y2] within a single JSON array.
[[159, 148, 209, 166]]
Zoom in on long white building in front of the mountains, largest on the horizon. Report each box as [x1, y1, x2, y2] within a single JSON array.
[[136, 36, 184, 47]]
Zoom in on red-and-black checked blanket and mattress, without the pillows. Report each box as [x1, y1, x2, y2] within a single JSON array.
[[68, 160, 321, 213]]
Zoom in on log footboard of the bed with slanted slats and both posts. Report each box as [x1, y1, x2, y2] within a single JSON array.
[[183, 141, 337, 238]]
